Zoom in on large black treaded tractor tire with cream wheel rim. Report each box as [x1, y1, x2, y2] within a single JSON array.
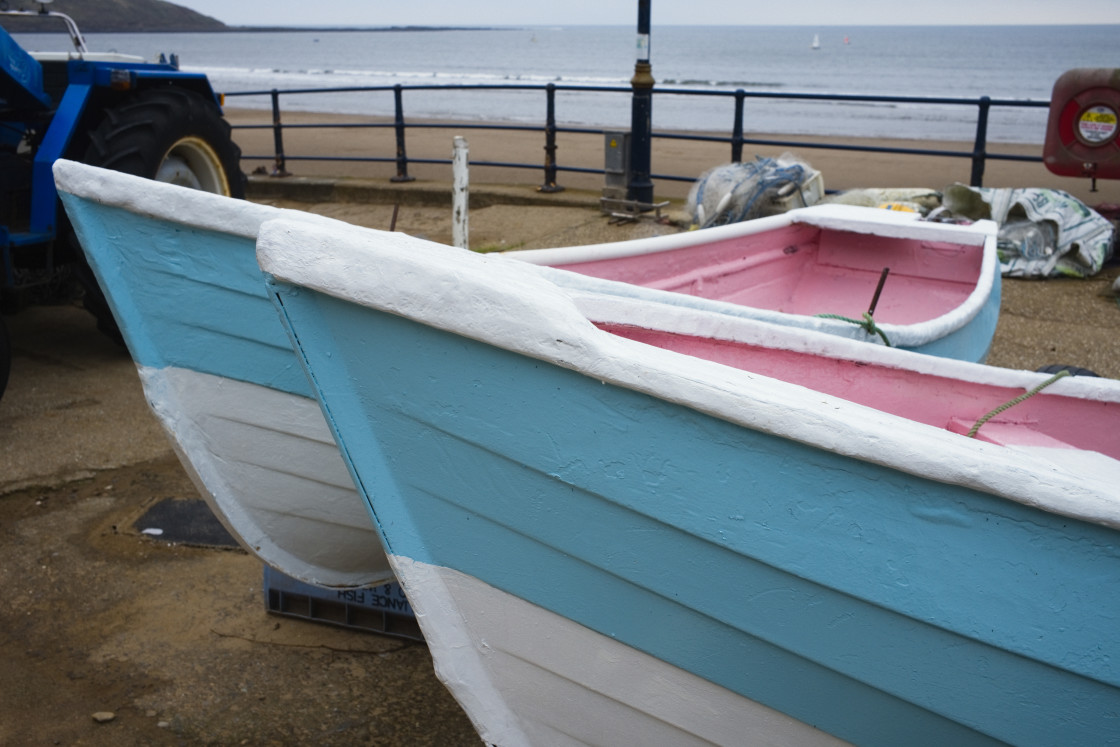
[[78, 87, 245, 342]]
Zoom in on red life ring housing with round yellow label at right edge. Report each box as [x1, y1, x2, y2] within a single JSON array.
[[1043, 67, 1120, 179]]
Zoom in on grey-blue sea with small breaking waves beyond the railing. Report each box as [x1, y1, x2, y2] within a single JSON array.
[[10, 25, 1120, 143]]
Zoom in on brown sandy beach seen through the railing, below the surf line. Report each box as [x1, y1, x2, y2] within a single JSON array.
[[226, 108, 1120, 206]]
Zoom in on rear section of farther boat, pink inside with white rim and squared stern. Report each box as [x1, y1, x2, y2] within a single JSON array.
[[503, 205, 1000, 362]]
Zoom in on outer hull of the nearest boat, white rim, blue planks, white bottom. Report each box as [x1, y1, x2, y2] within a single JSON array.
[[258, 222, 1120, 745]]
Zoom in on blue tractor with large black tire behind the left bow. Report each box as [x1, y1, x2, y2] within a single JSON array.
[[0, 0, 245, 396]]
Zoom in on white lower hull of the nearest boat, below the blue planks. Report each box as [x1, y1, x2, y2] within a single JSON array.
[[393, 557, 844, 747]]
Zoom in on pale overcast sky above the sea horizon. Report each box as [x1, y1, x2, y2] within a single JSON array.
[[165, 0, 1120, 29]]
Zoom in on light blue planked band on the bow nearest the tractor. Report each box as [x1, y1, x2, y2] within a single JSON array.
[[62, 192, 311, 396]]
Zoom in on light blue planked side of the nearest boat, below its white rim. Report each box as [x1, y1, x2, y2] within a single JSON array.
[[264, 229, 1120, 746]]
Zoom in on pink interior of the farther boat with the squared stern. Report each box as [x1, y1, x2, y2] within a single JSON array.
[[553, 223, 983, 325]]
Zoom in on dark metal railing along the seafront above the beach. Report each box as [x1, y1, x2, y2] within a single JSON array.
[[224, 83, 1049, 192]]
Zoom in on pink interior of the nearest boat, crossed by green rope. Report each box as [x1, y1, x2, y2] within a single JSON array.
[[596, 324, 1120, 459]]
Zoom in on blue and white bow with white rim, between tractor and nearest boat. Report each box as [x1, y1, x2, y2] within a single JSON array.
[[55, 161, 392, 587]]
